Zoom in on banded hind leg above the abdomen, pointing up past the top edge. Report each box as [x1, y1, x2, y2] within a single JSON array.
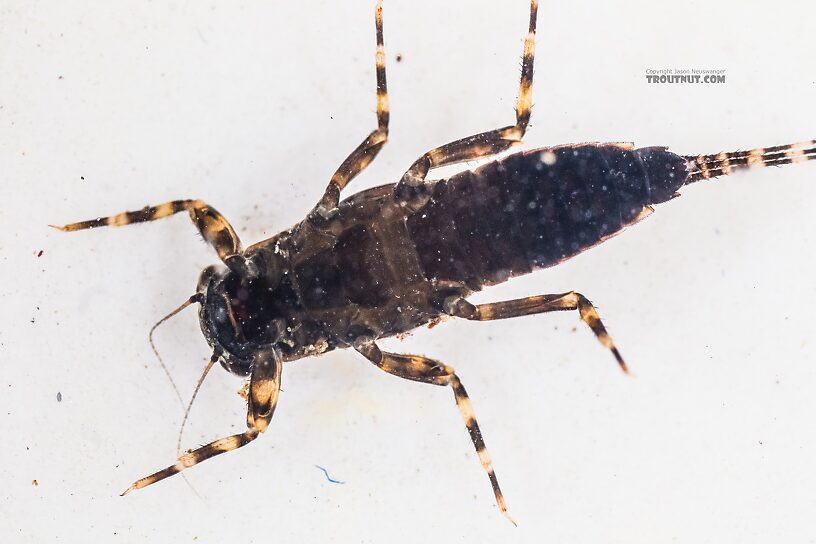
[[395, 0, 538, 199]]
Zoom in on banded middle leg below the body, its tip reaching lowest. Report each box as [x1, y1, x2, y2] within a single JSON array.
[[354, 340, 516, 525]]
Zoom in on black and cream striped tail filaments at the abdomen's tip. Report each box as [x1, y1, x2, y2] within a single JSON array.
[[683, 140, 816, 185]]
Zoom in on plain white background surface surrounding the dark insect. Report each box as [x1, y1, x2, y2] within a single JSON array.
[[0, 0, 816, 543]]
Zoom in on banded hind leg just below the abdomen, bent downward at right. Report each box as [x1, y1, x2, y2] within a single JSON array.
[[445, 291, 629, 373]]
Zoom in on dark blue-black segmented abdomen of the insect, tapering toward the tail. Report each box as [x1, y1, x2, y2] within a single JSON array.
[[408, 144, 687, 288]]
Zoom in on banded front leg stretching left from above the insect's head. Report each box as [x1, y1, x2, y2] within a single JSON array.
[[50, 200, 257, 275]]
